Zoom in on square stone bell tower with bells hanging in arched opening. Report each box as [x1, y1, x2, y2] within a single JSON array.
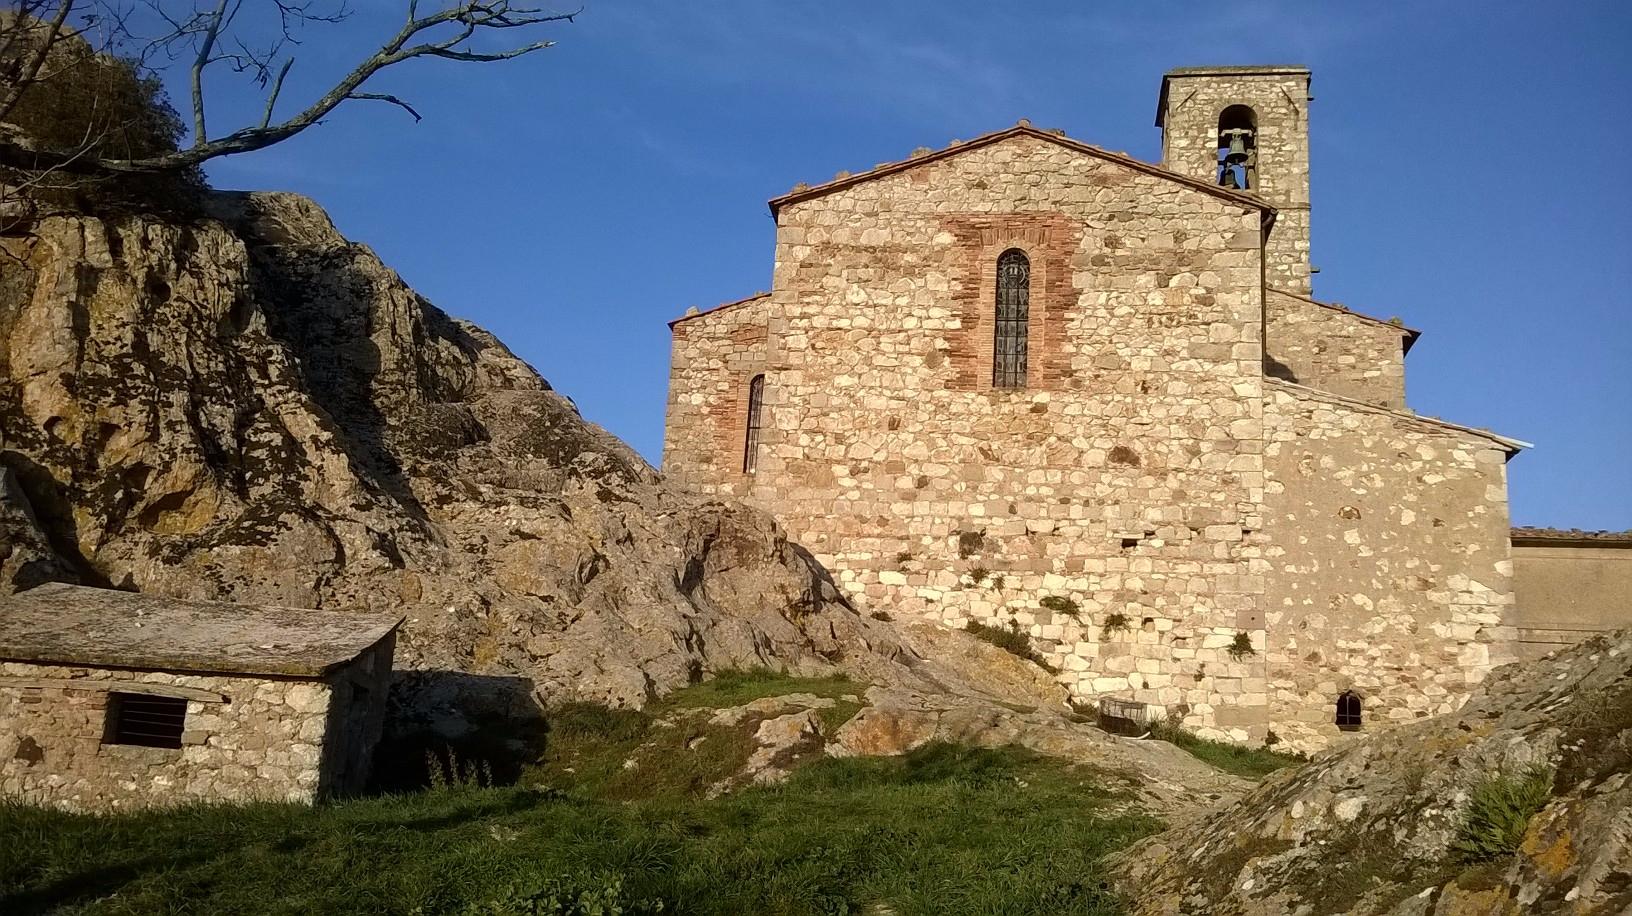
[[1155, 67, 1312, 296]]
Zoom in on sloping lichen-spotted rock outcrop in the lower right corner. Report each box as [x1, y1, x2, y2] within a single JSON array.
[[1118, 630, 1632, 916]]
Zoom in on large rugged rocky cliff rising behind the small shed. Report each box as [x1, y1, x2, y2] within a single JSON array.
[[0, 194, 894, 704]]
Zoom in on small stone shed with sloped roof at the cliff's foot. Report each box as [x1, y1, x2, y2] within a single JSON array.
[[0, 583, 401, 810]]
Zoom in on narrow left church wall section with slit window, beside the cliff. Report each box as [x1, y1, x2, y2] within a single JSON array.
[[663, 296, 770, 496]]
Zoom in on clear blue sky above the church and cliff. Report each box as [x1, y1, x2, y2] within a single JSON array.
[[176, 0, 1632, 527]]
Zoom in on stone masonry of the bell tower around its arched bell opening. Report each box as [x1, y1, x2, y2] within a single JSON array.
[[1162, 70, 1310, 296]]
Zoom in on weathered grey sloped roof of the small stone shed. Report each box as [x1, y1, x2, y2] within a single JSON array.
[[0, 583, 403, 678]]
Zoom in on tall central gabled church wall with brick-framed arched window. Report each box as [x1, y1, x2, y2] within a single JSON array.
[[747, 136, 1265, 740]]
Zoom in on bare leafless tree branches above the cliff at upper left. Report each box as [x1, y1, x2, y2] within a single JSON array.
[[0, 0, 576, 177]]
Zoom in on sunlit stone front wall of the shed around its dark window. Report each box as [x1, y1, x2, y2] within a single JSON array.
[[0, 661, 330, 810]]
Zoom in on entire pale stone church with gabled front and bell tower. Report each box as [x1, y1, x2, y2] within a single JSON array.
[[664, 67, 1524, 749]]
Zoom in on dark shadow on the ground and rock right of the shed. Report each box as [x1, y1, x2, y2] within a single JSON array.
[[372, 671, 548, 792]]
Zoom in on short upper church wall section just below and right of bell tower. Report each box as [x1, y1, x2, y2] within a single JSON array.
[[1263, 289, 1412, 408]]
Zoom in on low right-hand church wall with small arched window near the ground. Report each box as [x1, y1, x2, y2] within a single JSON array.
[[1265, 380, 1514, 749]]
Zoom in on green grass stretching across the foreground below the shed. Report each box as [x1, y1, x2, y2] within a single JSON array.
[[0, 744, 1159, 916]]
